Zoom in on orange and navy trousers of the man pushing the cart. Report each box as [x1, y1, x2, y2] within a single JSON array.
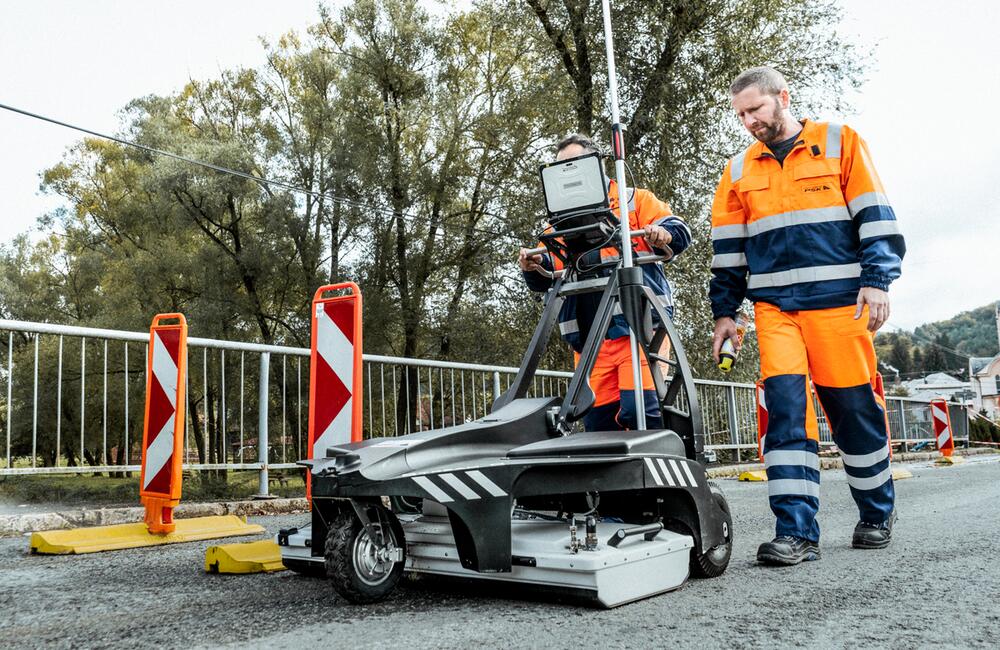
[[574, 336, 662, 431]]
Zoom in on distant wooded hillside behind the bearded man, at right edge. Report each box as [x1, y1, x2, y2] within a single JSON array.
[[875, 302, 998, 381]]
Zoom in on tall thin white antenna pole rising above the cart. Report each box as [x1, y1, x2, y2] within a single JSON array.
[[601, 0, 646, 430]]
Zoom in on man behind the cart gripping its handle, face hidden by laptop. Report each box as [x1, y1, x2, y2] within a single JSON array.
[[518, 134, 691, 431]]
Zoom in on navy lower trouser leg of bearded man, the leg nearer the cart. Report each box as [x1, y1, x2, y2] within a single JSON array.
[[764, 375, 819, 542]]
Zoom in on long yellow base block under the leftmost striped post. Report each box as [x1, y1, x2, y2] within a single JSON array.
[[31, 515, 264, 555]]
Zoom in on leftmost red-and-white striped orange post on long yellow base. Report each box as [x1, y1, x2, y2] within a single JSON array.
[[139, 314, 187, 535]]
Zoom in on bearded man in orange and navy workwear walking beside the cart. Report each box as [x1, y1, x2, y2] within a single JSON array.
[[709, 67, 906, 565]]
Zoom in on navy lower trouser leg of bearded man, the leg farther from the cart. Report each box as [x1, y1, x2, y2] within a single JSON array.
[[816, 384, 896, 524]]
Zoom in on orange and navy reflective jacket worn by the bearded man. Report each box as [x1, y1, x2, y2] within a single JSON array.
[[709, 120, 906, 318]]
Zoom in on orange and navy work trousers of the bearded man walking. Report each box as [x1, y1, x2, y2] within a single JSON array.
[[755, 302, 895, 541]]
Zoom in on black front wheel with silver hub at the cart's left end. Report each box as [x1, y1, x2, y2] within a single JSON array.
[[324, 505, 406, 605]]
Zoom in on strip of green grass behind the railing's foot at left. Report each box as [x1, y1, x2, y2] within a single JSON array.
[[0, 471, 306, 506]]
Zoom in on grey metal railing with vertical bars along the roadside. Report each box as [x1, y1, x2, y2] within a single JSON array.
[[0, 320, 968, 495]]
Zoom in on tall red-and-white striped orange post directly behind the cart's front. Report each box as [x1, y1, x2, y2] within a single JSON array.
[[306, 282, 363, 498]]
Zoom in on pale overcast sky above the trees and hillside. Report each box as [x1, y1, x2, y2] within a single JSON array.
[[0, 0, 1000, 329]]
